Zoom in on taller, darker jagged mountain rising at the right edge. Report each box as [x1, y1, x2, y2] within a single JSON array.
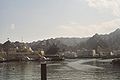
[[86, 28, 120, 50]]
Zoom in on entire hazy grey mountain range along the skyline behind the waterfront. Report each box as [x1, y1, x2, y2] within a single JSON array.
[[0, 28, 120, 51]]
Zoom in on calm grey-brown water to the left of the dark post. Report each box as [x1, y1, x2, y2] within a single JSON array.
[[0, 62, 40, 80]]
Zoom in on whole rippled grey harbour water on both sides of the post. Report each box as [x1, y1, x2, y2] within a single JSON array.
[[0, 59, 120, 80]]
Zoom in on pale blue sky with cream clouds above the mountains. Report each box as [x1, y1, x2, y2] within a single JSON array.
[[0, 0, 120, 43]]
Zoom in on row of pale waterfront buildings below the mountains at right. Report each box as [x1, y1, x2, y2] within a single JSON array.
[[62, 48, 120, 58]]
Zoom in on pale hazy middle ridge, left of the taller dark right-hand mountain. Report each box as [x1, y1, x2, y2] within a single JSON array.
[[28, 38, 89, 50]]
